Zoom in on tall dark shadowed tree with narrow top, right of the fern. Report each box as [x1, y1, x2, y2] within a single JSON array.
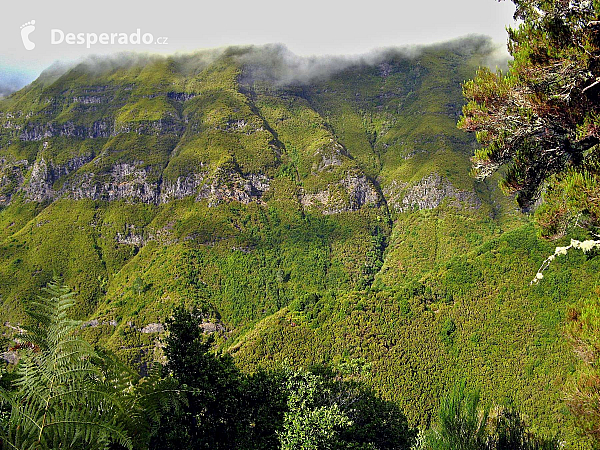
[[150, 307, 249, 449]]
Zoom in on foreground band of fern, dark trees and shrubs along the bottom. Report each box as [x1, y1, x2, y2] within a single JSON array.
[[0, 280, 561, 450]]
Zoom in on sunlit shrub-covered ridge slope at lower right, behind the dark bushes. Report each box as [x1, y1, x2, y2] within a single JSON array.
[[229, 225, 598, 449]]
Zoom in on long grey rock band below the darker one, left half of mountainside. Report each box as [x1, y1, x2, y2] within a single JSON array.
[[8, 155, 270, 206]]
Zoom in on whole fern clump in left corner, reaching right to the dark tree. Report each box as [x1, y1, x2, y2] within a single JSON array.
[[0, 278, 179, 449]]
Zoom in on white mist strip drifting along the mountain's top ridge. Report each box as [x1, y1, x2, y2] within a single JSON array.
[[7, 35, 509, 96]]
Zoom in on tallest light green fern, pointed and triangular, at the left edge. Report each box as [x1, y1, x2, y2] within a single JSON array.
[[1, 280, 133, 449]]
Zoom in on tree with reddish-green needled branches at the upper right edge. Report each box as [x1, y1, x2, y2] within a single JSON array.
[[458, 0, 600, 236]]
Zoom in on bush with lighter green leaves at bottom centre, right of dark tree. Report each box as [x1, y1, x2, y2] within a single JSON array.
[[279, 360, 415, 450]]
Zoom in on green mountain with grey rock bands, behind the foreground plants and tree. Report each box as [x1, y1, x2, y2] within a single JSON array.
[[0, 38, 598, 448]]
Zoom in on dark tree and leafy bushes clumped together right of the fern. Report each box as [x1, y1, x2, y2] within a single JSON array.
[[150, 308, 414, 450]]
